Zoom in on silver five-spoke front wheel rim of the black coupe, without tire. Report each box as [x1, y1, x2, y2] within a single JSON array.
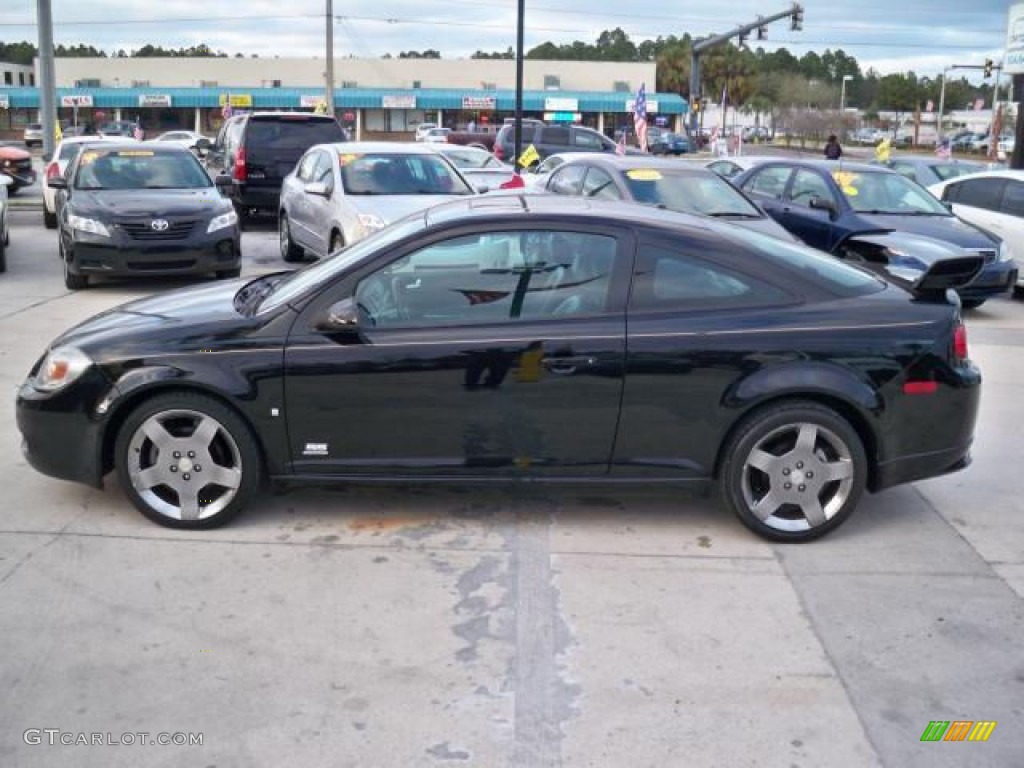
[[128, 410, 242, 520]]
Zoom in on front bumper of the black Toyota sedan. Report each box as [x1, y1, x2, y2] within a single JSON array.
[[68, 227, 242, 276]]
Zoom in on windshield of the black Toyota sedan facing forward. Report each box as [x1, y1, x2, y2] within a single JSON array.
[[75, 148, 213, 189]]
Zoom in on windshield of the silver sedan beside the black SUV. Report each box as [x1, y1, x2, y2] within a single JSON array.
[[338, 153, 474, 195]]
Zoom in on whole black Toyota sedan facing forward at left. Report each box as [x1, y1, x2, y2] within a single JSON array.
[[47, 142, 242, 291]]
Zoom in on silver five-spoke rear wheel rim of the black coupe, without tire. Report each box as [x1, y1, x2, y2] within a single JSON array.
[[741, 422, 855, 531]]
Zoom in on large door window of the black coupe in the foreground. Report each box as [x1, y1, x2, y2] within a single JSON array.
[[355, 230, 616, 328]]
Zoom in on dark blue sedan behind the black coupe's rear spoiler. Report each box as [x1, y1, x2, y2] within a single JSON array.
[[732, 158, 1017, 309]]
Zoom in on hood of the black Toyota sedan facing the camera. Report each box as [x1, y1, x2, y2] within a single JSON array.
[[69, 187, 231, 217]]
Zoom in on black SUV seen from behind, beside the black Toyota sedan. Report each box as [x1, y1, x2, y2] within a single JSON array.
[[200, 112, 348, 220]]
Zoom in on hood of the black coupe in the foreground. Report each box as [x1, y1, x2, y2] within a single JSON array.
[[51, 279, 253, 360]]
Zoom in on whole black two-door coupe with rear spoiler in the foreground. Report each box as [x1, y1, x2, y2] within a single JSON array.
[[17, 196, 981, 542]]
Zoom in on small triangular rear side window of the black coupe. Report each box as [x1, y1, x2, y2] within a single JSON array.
[[630, 244, 792, 310]]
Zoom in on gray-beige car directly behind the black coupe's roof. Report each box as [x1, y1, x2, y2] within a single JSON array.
[[546, 155, 797, 242]]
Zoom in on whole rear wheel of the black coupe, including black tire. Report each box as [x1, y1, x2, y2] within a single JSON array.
[[720, 400, 867, 543]]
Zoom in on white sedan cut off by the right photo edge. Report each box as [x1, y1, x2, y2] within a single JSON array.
[[928, 170, 1024, 290]]
